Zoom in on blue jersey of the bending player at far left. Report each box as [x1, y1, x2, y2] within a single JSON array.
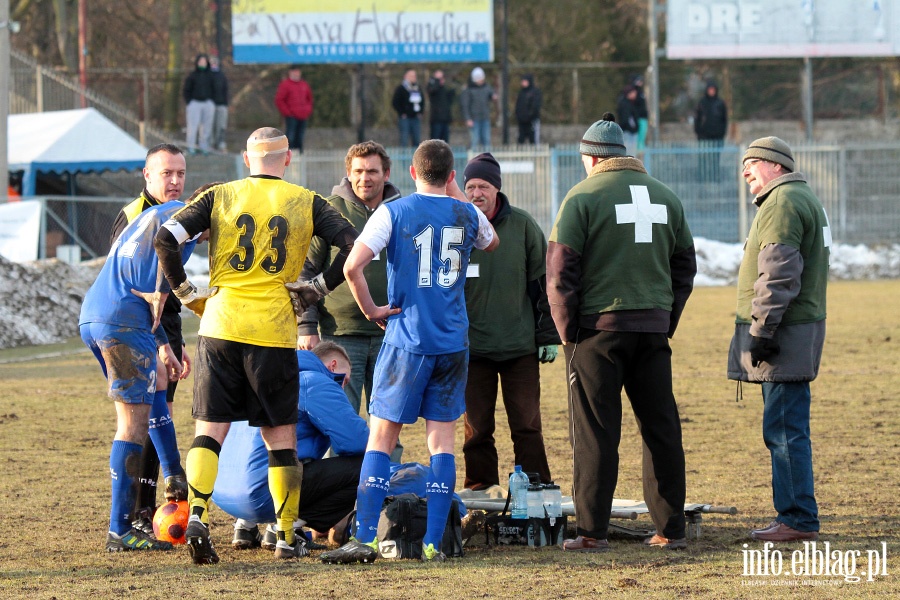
[[78, 200, 196, 331]]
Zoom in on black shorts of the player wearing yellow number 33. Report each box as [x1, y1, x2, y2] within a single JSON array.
[[193, 336, 300, 427]]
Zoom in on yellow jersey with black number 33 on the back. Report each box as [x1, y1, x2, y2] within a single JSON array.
[[200, 177, 315, 348]]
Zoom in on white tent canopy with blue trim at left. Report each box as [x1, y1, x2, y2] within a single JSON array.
[[7, 108, 147, 196]]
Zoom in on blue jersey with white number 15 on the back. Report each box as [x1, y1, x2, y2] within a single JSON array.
[[382, 194, 479, 354]]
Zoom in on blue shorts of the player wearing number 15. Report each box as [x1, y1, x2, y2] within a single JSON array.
[[369, 344, 469, 425]]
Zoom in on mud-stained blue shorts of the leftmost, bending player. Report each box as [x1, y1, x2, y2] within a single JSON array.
[[81, 323, 156, 404]]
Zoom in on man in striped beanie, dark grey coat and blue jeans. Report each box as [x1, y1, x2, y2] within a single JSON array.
[[728, 137, 831, 542]]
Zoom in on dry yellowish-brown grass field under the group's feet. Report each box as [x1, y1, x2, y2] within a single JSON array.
[[0, 281, 900, 600]]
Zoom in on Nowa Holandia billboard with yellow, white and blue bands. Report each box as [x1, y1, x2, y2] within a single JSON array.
[[231, 0, 494, 64]]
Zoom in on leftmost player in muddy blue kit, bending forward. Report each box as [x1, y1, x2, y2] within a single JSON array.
[[78, 189, 209, 552]]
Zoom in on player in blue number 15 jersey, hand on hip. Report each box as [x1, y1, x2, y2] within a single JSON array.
[[321, 140, 500, 563]]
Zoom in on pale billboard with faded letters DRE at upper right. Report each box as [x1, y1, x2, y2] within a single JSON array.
[[666, 0, 900, 59]]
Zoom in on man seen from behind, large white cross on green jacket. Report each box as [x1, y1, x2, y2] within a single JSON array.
[[547, 113, 697, 552]]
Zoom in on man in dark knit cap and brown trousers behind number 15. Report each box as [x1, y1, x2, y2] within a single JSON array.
[[463, 153, 559, 490]]
